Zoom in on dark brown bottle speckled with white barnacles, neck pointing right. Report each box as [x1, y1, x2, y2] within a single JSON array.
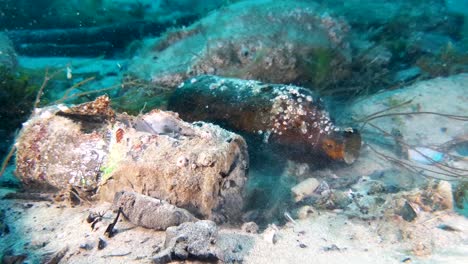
[[169, 75, 361, 164]]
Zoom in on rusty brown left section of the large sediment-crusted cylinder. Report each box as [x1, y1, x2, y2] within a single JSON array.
[[15, 97, 114, 190]]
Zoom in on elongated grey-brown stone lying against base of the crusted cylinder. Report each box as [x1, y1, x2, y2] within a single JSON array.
[[114, 192, 196, 230]]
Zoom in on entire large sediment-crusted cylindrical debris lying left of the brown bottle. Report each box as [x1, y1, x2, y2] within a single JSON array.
[[16, 97, 249, 222]]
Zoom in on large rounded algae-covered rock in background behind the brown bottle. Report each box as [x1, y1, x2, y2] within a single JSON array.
[[129, 0, 351, 91]]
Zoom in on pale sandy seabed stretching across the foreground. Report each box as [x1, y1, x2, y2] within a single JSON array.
[[0, 186, 468, 263]]
